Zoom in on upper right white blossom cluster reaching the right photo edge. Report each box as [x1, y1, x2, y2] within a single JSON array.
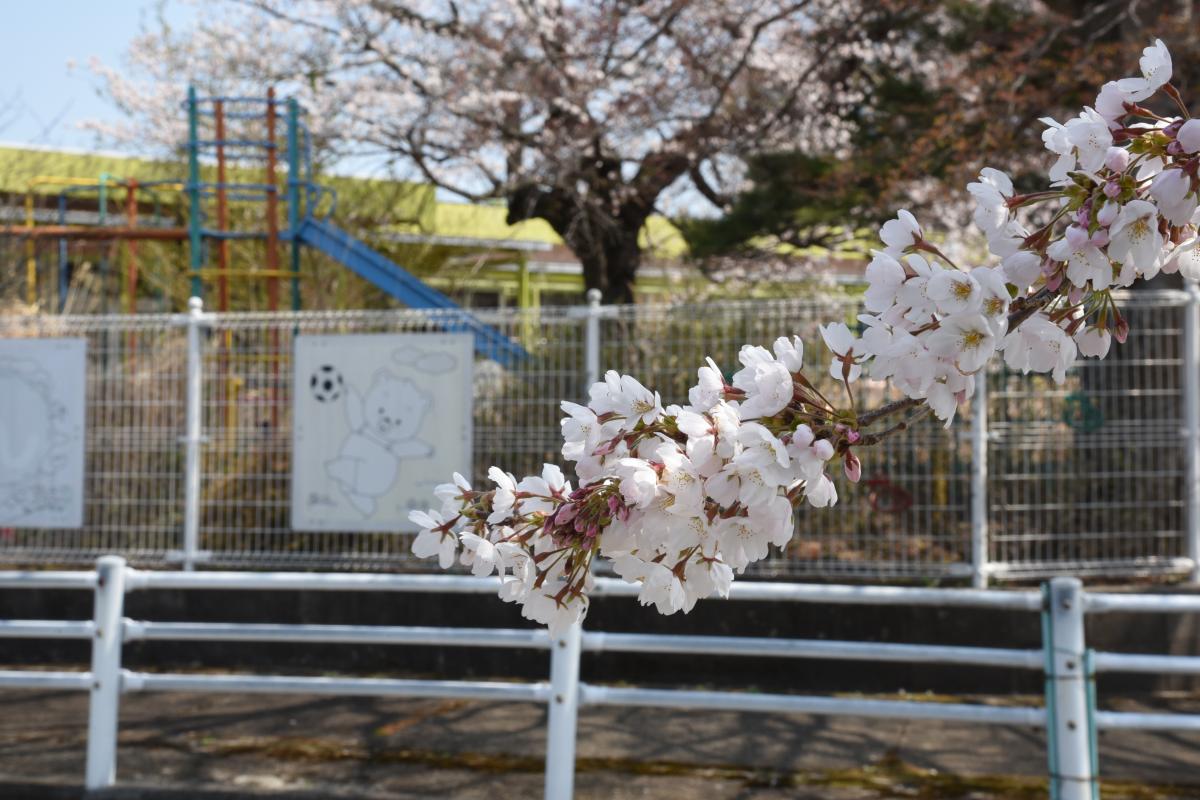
[[844, 41, 1200, 423]]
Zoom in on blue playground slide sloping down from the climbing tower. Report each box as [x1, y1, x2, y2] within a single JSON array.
[[296, 217, 529, 367]]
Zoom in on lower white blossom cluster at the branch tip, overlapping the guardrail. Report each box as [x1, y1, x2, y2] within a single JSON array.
[[413, 347, 844, 630]]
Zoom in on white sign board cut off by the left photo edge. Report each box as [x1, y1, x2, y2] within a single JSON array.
[[0, 339, 88, 528]]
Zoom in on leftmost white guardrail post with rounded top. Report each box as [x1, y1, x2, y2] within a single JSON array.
[[84, 555, 125, 790]]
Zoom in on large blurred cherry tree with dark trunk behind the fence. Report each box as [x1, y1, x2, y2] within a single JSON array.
[[95, 0, 944, 302]]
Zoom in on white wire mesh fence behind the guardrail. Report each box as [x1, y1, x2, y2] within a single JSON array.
[[0, 291, 1200, 585]]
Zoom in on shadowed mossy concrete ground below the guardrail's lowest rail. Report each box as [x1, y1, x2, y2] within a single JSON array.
[[0, 691, 1200, 800]]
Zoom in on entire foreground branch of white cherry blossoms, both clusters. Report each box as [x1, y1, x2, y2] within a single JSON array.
[[412, 41, 1200, 630]]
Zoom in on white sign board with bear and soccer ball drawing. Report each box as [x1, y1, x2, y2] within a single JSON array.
[[292, 333, 474, 531]]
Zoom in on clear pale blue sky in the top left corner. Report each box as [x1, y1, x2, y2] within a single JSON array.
[[0, 0, 187, 148]]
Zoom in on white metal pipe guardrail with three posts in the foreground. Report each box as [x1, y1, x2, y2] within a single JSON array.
[[7, 557, 1200, 800]]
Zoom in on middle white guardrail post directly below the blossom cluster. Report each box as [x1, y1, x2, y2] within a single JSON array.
[[545, 622, 583, 800]]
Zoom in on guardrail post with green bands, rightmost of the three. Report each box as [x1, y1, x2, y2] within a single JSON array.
[[1042, 578, 1099, 800]]
